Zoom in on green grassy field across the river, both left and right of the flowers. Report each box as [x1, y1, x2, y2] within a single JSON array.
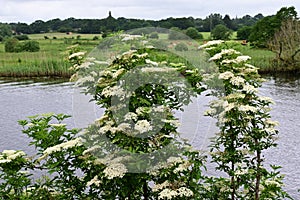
[[0, 32, 274, 77]]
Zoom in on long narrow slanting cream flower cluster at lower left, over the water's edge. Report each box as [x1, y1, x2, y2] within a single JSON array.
[[38, 137, 83, 161]]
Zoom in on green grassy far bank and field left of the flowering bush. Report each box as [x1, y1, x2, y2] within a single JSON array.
[[0, 33, 100, 77]]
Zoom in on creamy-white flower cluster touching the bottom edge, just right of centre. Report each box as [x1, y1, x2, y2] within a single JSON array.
[[158, 187, 194, 199]]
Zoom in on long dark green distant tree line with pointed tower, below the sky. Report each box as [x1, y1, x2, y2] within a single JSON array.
[[0, 12, 264, 34]]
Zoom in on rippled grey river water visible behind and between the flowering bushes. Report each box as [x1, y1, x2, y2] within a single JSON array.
[[0, 75, 300, 199]]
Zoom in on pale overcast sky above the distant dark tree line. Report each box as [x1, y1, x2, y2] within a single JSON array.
[[0, 0, 300, 23]]
